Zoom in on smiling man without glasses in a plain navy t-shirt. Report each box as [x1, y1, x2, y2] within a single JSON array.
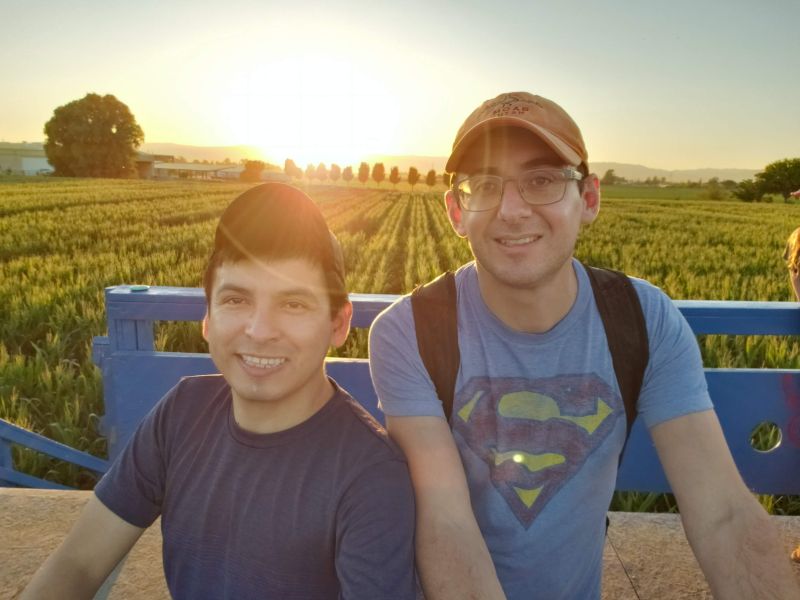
[[23, 183, 414, 600]]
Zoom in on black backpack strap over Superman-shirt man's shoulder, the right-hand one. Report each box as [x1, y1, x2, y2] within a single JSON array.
[[584, 265, 650, 440]]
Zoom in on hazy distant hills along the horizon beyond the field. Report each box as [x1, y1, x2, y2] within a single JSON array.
[[0, 142, 760, 183]]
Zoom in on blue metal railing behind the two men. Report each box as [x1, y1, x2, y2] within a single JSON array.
[[0, 286, 800, 494]]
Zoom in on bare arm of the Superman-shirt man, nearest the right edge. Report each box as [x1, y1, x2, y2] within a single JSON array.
[[650, 410, 800, 600]]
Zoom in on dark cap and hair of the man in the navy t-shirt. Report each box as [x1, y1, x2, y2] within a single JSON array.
[[203, 182, 347, 317]]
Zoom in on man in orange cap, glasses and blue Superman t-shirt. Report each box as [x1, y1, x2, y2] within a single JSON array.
[[370, 92, 798, 600]]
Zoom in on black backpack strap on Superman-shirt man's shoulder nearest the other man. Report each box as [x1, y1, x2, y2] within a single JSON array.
[[411, 271, 461, 422]]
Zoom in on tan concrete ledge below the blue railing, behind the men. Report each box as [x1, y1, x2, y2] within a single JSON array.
[[0, 488, 800, 600]]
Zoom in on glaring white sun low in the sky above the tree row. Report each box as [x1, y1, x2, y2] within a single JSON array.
[[220, 53, 399, 168]]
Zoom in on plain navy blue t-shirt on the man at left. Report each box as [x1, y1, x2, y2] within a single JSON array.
[[95, 375, 414, 600]]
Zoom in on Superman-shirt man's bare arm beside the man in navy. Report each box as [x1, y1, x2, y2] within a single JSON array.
[[386, 416, 505, 600]]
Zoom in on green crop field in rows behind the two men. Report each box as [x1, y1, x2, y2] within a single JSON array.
[[0, 178, 800, 515]]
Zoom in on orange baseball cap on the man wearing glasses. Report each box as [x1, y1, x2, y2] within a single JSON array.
[[445, 92, 589, 173]]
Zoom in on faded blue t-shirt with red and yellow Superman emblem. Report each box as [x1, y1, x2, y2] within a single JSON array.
[[370, 261, 711, 600]]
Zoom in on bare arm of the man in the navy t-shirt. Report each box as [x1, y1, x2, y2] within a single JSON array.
[[20, 494, 144, 600]]
